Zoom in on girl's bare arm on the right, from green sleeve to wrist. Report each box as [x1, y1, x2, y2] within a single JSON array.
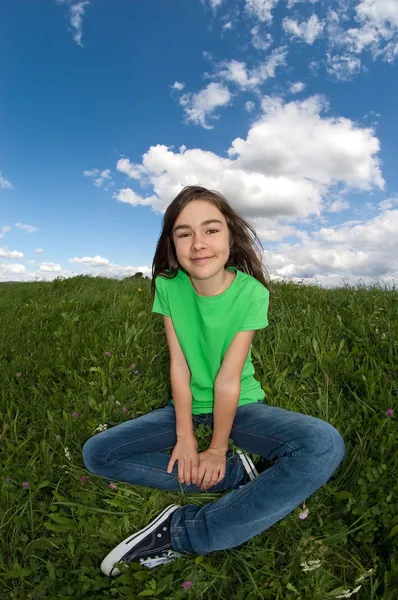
[[209, 330, 255, 452]]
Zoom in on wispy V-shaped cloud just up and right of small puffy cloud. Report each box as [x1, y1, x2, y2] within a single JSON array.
[[217, 46, 287, 90]]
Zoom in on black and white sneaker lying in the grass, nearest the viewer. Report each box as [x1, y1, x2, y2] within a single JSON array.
[[101, 504, 181, 577]]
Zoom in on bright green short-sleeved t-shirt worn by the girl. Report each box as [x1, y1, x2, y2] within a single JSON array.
[[152, 267, 269, 415]]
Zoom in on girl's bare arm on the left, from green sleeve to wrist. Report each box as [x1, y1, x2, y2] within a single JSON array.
[[163, 316, 194, 439]]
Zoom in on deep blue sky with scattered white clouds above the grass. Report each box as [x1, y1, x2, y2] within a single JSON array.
[[0, 0, 398, 287]]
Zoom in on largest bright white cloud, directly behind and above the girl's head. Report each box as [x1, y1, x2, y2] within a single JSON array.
[[114, 96, 384, 220]]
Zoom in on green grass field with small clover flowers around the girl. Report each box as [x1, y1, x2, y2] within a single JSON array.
[[0, 276, 398, 600]]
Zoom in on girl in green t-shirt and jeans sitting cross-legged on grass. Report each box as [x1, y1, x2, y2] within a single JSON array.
[[83, 186, 345, 576]]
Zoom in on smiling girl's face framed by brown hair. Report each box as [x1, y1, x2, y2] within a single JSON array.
[[173, 200, 230, 279]]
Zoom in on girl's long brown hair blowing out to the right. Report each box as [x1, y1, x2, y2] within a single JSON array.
[[151, 185, 272, 294]]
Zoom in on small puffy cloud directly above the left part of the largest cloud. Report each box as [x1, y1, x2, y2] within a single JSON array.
[[179, 82, 232, 129]]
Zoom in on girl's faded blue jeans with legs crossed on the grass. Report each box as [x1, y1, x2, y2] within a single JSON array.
[[83, 401, 345, 554]]
